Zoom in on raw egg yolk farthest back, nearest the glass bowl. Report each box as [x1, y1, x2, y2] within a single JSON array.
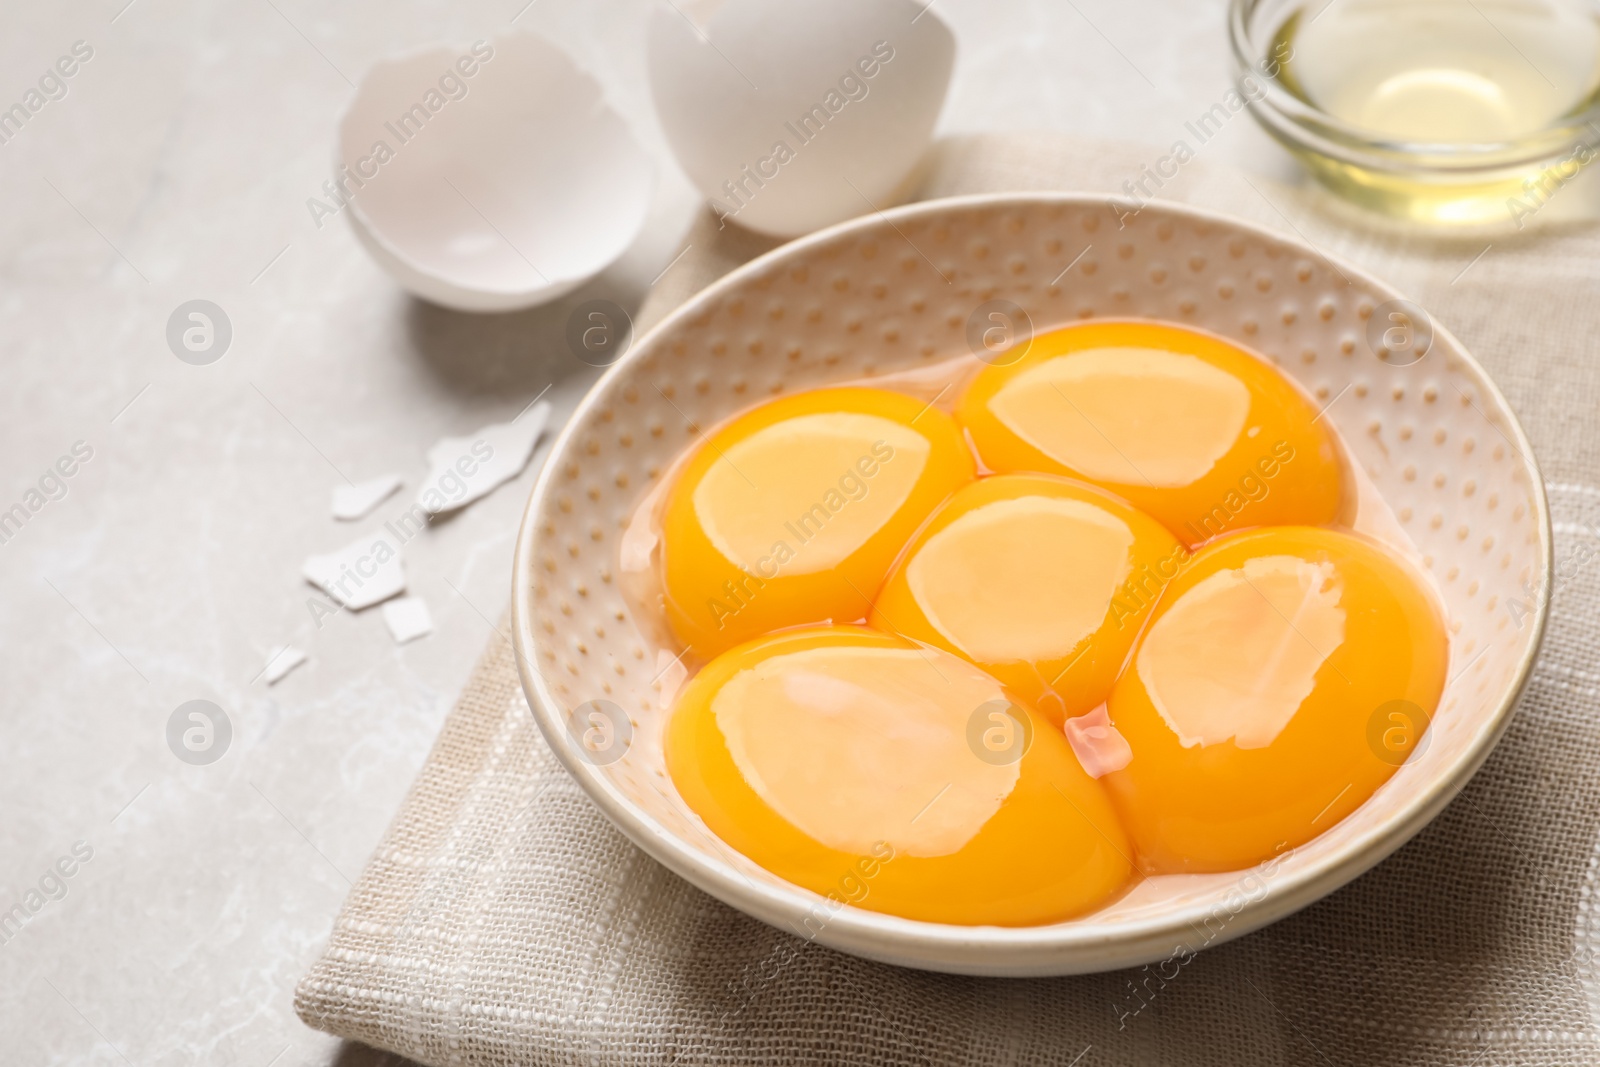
[[957, 322, 1341, 547]]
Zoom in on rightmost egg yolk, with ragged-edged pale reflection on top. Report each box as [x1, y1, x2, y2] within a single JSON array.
[[1100, 526, 1448, 873]]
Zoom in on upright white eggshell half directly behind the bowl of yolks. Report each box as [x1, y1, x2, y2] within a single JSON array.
[[648, 0, 955, 237]]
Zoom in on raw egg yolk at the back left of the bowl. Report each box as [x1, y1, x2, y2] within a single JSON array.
[[661, 389, 973, 659]]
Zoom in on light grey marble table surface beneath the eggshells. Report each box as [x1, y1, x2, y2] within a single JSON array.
[[0, 0, 1293, 1067]]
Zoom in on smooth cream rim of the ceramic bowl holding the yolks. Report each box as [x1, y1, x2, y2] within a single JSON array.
[[510, 192, 1554, 976]]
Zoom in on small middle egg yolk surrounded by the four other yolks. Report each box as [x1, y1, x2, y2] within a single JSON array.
[[869, 475, 1187, 728]]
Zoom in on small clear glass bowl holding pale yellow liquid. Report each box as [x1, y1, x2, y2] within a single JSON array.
[[1229, 0, 1600, 229]]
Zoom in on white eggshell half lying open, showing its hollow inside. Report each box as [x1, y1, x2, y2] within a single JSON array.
[[334, 32, 654, 312]]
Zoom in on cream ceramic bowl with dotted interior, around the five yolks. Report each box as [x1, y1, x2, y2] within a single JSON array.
[[509, 194, 1550, 976]]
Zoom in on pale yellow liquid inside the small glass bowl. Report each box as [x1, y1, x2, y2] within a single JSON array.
[[1272, 0, 1600, 222]]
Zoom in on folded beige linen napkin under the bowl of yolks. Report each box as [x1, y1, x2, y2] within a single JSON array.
[[296, 136, 1600, 1067]]
